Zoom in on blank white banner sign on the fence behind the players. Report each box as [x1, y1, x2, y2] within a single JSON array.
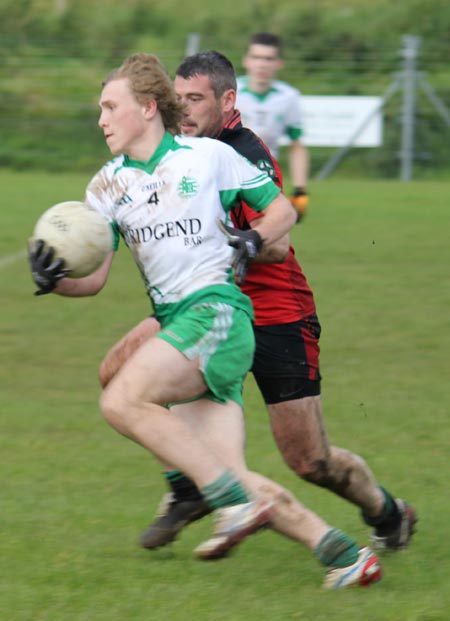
[[301, 95, 383, 147]]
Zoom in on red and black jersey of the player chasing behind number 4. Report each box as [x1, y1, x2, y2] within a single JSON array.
[[217, 110, 315, 326]]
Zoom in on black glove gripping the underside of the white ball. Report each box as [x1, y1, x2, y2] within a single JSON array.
[[28, 239, 70, 295]]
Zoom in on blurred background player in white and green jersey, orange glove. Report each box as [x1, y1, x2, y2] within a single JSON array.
[[236, 32, 309, 220]]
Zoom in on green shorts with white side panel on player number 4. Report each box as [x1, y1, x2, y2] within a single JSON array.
[[157, 302, 255, 404]]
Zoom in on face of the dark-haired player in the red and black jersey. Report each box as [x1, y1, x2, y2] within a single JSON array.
[[174, 75, 235, 138]]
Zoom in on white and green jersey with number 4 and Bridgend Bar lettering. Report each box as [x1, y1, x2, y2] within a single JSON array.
[[85, 133, 279, 314]]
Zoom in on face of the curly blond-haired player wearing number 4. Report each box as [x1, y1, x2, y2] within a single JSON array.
[[98, 78, 147, 159]]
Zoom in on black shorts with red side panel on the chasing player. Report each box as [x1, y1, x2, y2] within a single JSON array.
[[252, 315, 321, 405]]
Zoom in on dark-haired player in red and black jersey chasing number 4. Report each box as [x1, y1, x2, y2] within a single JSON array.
[[100, 51, 417, 549]]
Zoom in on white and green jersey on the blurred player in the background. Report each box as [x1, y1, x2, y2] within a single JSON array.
[[236, 76, 303, 157]]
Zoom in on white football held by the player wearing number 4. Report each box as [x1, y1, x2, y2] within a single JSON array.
[[32, 201, 113, 278]]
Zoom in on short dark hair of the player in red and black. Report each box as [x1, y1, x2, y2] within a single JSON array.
[[176, 50, 237, 99]]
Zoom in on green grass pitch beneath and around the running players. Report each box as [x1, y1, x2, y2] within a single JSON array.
[[0, 171, 450, 621]]
